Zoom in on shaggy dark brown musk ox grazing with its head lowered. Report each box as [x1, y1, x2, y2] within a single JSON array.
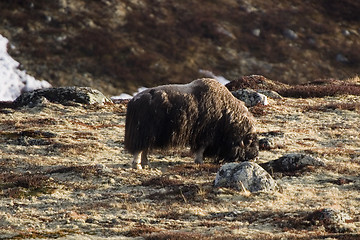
[[125, 78, 259, 169]]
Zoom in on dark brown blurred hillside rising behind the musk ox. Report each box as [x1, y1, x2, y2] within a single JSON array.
[[0, 0, 360, 95]]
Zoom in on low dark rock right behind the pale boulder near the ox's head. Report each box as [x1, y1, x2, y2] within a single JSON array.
[[261, 153, 325, 172]]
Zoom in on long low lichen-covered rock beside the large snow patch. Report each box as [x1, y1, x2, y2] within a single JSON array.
[[14, 87, 112, 107]]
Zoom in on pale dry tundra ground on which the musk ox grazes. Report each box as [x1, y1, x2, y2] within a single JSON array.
[[0, 78, 360, 240]]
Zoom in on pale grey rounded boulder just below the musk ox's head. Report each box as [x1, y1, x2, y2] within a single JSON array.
[[214, 162, 281, 193]]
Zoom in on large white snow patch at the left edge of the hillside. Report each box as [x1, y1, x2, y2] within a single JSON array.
[[0, 34, 51, 101]]
